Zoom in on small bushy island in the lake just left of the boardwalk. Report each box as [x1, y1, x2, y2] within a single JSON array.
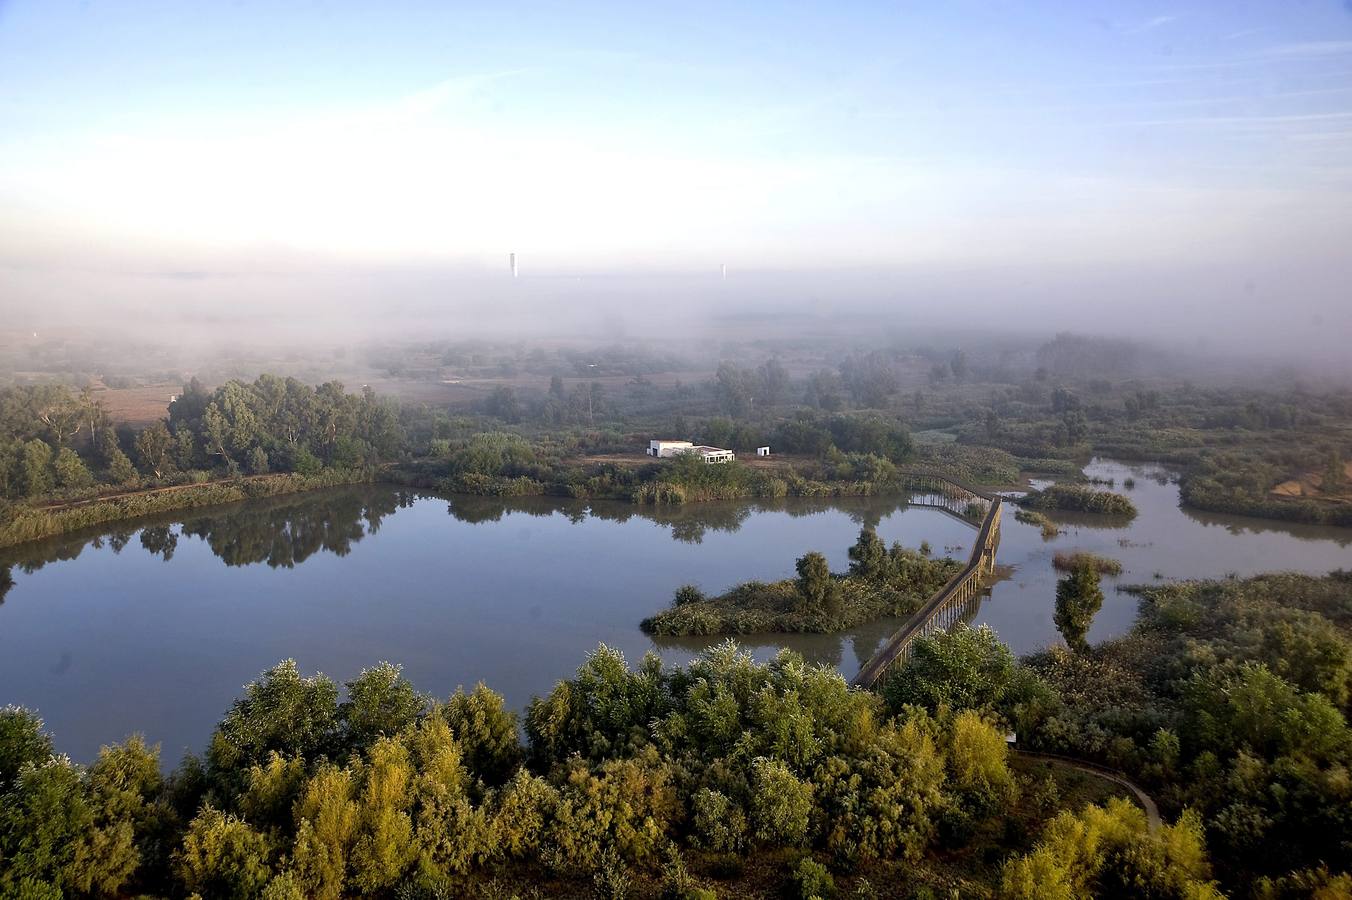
[[642, 528, 961, 635]]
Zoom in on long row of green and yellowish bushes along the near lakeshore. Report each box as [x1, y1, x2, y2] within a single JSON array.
[[0, 645, 1014, 897]]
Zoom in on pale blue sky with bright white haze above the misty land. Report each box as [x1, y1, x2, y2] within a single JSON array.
[[0, 0, 1352, 349]]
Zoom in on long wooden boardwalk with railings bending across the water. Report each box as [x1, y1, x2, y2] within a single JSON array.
[[853, 473, 1000, 688]]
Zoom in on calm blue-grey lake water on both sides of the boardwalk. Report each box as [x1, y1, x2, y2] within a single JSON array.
[[0, 464, 1352, 764]]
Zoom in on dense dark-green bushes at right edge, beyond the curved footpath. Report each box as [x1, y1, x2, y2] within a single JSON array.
[[1026, 574, 1352, 884]]
